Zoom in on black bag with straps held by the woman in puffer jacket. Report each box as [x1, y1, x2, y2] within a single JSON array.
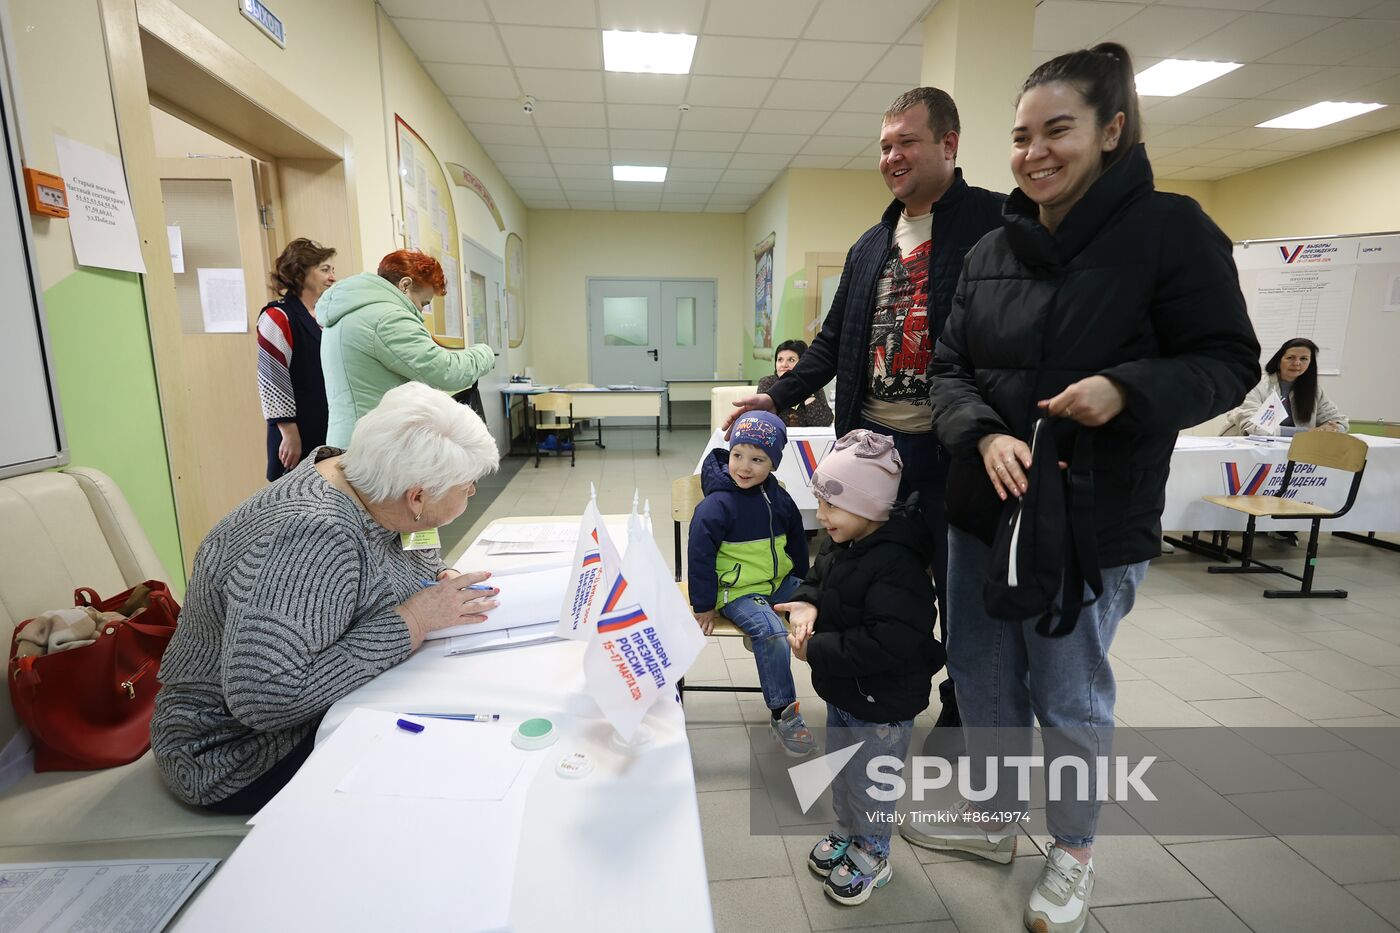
[[983, 417, 1103, 637]]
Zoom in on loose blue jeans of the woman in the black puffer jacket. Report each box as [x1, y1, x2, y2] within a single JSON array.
[[946, 528, 1147, 846]]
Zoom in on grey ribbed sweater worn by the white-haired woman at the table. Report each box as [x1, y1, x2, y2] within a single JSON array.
[[151, 447, 444, 804]]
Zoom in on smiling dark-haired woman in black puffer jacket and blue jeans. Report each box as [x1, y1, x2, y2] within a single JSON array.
[[906, 43, 1259, 930]]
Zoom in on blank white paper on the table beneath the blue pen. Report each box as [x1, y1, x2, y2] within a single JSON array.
[[336, 713, 533, 800]]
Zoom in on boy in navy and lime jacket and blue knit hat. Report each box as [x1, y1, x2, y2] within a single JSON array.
[[687, 412, 816, 758]]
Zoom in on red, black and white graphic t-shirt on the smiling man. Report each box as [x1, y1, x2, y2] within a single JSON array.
[[862, 212, 934, 434]]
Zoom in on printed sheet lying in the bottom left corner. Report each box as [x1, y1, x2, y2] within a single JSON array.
[[0, 859, 218, 933]]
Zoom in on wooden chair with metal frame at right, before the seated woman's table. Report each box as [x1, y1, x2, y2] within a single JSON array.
[[1203, 431, 1369, 600]]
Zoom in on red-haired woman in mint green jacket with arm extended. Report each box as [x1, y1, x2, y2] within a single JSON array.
[[316, 249, 496, 448]]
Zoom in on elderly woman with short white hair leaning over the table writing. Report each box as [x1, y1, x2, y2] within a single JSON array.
[[151, 382, 498, 814]]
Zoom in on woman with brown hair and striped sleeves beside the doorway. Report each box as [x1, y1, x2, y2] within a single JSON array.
[[258, 237, 336, 482]]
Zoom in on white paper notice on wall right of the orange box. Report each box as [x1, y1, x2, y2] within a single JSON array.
[[53, 136, 146, 275]]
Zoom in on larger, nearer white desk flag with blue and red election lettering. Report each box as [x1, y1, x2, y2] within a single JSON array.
[[584, 511, 704, 740]]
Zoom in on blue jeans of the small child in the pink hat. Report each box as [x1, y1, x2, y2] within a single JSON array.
[[826, 703, 914, 859]]
